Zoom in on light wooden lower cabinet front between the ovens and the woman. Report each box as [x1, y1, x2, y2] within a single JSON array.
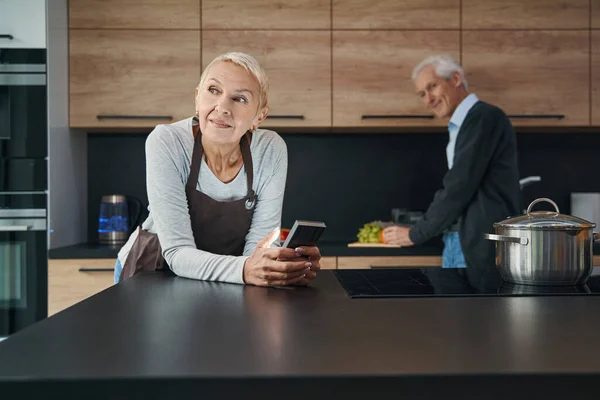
[[48, 259, 115, 316]]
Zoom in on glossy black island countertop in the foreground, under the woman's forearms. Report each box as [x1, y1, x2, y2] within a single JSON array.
[[0, 271, 600, 400]]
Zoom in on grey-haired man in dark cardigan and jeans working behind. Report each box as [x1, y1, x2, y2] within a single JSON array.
[[384, 55, 521, 283]]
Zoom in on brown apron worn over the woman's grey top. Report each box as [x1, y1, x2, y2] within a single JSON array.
[[119, 129, 257, 282]]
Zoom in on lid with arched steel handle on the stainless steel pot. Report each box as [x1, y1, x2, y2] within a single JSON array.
[[494, 198, 596, 230]]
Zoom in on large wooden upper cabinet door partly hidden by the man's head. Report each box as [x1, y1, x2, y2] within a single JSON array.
[[333, 31, 460, 127]]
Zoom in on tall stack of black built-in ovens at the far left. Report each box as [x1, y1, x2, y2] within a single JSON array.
[[0, 48, 48, 337]]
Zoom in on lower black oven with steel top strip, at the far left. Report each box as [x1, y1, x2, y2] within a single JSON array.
[[0, 203, 48, 337]]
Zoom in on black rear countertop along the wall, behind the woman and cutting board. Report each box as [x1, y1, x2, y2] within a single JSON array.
[[48, 239, 443, 259]]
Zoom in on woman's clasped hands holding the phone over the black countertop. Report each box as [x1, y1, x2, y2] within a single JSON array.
[[244, 229, 312, 286]]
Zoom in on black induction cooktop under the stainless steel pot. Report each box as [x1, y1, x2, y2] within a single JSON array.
[[334, 267, 600, 298]]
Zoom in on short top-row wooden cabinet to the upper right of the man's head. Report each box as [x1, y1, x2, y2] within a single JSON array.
[[462, 0, 590, 29]]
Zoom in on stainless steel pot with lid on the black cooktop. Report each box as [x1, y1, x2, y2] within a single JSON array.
[[484, 198, 600, 285]]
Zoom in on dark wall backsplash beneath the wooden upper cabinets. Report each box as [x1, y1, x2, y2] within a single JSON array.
[[88, 133, 600, 242]]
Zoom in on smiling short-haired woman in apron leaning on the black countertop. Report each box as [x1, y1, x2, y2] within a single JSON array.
[[115, 53, 321, 286]]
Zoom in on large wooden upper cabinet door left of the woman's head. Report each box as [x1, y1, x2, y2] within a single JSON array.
[[69, 30, 200, 128]]
